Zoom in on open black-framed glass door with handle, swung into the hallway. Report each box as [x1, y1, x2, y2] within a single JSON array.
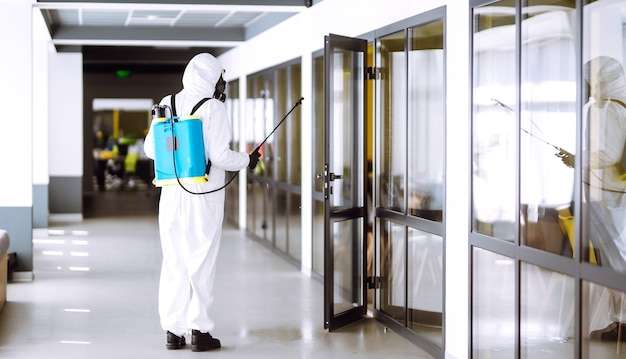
[[318, 35, 367, 331]]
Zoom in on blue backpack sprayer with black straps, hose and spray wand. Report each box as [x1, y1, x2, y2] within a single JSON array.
[[152, 95, 304, 194]]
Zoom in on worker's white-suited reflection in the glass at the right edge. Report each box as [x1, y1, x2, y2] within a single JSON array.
[[582, 56, 626, 331]]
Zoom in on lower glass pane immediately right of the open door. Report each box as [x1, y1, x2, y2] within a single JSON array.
[[378, 220, 406, 325]]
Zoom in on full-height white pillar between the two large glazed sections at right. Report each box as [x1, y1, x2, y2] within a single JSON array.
[[444, 6, 471, 359]]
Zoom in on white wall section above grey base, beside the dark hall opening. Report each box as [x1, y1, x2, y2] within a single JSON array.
[[48, 51, 83, 177]]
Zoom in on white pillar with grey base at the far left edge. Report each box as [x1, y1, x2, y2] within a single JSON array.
[[0, 0, 33, 279]]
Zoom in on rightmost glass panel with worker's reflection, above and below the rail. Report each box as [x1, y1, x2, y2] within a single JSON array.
[[581, 0, 626, 358]]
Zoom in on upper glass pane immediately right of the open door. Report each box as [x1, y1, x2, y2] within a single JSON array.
[[377, 31, 408, 213]]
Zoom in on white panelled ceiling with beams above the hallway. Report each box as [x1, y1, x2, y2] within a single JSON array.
[[33, 0, 312, 72]]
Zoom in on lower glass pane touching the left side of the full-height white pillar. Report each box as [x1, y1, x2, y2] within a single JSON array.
[[407, 228, 443, 344]]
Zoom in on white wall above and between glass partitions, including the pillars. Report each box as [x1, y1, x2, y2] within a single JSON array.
[[220, 0, 471, 359]]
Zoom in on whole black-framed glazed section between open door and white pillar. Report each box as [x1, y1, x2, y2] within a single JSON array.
[[368, 13, 446, 348]]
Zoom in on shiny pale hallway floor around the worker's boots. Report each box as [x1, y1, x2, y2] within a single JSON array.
[[0, 191, 430, 359]]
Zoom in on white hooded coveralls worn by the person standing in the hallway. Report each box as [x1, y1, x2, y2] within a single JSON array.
[[144, 53, 250, 336]]
